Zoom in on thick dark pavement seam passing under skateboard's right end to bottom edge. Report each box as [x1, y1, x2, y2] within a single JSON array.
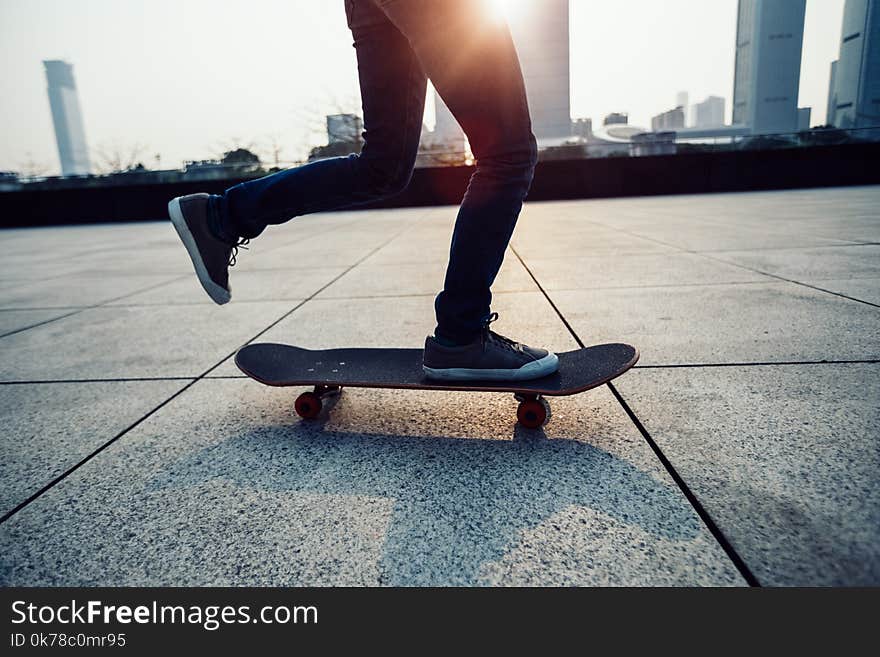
[[511, 243, 761, 587]]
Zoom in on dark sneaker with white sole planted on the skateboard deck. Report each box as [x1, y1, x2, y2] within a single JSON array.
[[423, 313, 559, 381]]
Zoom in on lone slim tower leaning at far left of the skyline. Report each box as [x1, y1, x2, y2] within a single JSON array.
[[43, 60, 92, 176]]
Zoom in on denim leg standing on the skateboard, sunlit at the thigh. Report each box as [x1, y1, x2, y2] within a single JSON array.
[[373, 0, 537, 342]]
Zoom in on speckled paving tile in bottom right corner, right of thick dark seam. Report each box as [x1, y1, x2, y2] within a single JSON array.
[[616, 364, 880, 586]]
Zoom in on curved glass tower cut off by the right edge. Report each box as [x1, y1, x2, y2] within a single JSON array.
[[827, 0, 880, 128]]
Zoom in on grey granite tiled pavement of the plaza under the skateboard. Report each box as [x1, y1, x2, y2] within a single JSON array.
[[0, 187, 880, 585]]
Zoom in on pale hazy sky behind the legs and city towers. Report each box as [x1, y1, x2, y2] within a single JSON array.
[[0, 0, 844, 174]]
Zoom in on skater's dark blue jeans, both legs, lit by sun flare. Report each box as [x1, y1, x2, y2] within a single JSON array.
[[212, 0, 537, 343]]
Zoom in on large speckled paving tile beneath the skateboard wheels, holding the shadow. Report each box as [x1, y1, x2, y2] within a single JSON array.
[[0, 380, 743, 586]]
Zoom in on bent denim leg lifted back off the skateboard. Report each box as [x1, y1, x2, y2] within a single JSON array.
[[214, 0, 427, 238]]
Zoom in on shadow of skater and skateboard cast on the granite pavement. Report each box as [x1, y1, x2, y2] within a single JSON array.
[[151, 410, 700, 586]]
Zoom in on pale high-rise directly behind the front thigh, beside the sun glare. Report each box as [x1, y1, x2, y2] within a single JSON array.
[[510, 0, 571, 146]]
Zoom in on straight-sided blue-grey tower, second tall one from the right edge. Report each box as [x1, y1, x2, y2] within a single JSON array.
[[733, 0, 807, 134]]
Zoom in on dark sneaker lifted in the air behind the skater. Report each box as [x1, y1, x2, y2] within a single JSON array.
[[168, 194, 248, 305]]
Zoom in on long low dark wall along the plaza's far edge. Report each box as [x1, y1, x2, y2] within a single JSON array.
[[0, 143, 880, 227]]
